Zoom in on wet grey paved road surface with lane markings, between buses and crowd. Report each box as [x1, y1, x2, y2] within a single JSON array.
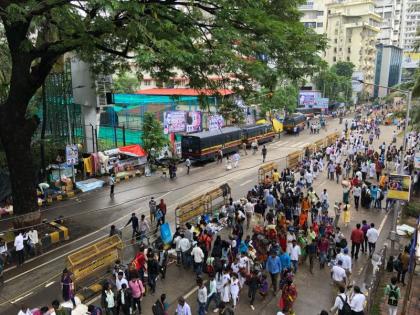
[[0, 116, 398, 314]]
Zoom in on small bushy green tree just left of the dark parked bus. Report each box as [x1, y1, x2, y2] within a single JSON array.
[[143, 113, 168, 153]]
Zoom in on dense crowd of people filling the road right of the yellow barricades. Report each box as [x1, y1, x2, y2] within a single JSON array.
[[13, 105, 419, 315]]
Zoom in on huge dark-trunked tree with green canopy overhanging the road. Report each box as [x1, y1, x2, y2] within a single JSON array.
[[0, 0, 326, 218]]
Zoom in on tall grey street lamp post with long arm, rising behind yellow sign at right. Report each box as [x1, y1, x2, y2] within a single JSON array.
[[353, 79, 412, 253]]
